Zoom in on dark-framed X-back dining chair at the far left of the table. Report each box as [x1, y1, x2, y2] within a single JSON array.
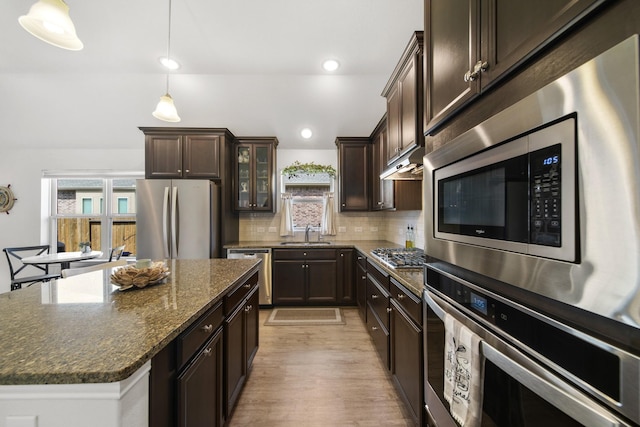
[[2, 245, 60, 291]]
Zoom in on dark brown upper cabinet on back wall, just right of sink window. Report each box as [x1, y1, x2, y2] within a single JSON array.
[[336, 137, 371, 212]]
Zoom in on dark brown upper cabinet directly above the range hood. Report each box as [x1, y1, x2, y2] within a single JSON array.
[[382, 31, 424, 164]]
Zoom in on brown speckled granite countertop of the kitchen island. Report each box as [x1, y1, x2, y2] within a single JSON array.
[[0, 259, 260, 385]]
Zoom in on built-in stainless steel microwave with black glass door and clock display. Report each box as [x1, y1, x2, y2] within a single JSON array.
[[433, 114, 578, 262]]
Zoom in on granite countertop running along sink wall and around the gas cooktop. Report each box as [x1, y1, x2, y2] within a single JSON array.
[[225, 239, 424, 297]]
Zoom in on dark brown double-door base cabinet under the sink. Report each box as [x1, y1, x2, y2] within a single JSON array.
[[272, 249, 338, 305]]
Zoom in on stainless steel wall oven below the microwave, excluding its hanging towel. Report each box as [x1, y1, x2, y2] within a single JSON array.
[[423, 263, 640, 427]]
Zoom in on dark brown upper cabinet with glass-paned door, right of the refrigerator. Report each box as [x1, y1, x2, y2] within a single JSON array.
[[233, 137, 278, 212]]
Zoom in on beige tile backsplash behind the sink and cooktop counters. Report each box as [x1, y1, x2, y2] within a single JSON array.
[[240, 211, 424, 248]]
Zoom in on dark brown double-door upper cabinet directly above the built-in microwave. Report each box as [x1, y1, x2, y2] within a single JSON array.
[[424, 0, 608, 133]]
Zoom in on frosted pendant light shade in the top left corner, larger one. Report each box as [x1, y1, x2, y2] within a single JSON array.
[[18, 0, 84, 50]]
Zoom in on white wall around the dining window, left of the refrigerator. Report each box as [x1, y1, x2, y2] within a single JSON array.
[[0, 148, 144, 292]]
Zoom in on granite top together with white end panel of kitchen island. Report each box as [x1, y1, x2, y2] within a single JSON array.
[[0, 259, 259, 427]]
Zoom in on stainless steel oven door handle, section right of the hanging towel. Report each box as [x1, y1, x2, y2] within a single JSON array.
[[480, 341, 626, 427]]
